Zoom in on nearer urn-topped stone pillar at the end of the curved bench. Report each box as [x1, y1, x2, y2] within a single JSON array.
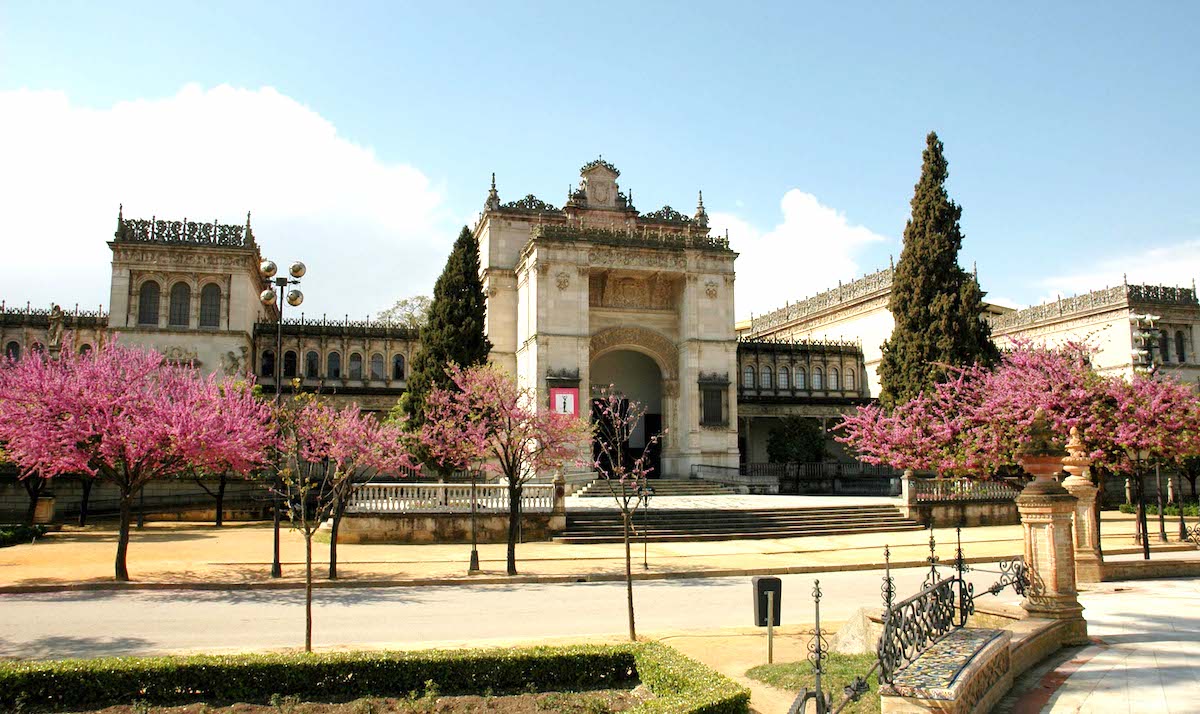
[[1016, 455, 1087, 644]]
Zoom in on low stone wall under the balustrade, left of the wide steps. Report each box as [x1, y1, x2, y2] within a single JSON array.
[[337, 514, 566, 544]]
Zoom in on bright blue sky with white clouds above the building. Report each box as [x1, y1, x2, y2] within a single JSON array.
[[0, 1, 1200, 317]]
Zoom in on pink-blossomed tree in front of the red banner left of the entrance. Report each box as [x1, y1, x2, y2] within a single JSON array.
[[421, 365, 587, 575]]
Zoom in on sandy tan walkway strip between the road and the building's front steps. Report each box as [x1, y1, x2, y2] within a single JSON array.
[[0, 508, 1186, 593]]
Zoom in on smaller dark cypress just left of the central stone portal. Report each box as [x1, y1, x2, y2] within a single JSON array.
[[398, 226, 492, 428]]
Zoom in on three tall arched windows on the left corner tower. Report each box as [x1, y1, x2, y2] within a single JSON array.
[[128, 274, 229, 330]]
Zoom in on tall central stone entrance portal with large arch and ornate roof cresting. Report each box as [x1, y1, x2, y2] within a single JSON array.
[[474, 160, 738, 475]]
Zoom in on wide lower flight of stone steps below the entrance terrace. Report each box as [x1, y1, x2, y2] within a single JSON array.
[[554, 506, 922, 544]]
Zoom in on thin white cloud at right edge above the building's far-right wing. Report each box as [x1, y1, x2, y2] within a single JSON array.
[[1038, 239, 1200, 302]]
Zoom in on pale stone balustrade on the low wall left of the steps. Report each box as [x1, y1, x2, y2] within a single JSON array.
[[346, 484, 554, 514]]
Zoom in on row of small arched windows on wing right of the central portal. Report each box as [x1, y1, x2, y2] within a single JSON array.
[[738, 353, 863, 397]]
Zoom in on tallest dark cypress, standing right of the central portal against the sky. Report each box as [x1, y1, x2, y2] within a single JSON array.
[[880, 132, 1000, 407]]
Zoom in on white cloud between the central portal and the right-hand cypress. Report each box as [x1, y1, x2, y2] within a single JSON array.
[[710, 188, 890, 319]]
